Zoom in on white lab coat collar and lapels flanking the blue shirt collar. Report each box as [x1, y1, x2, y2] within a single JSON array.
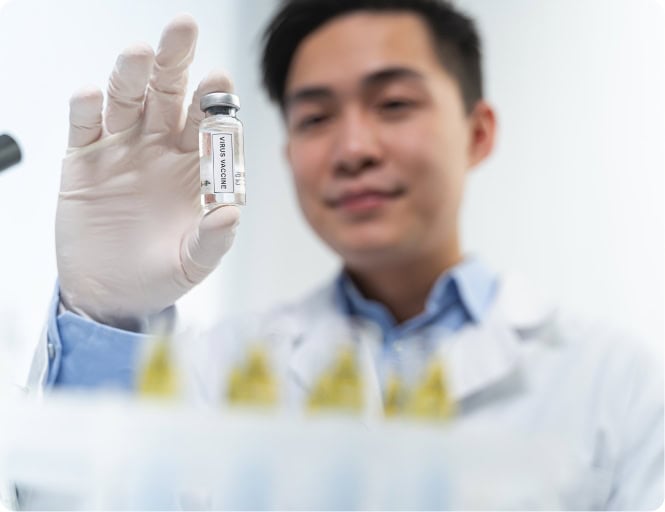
[[290, 274, 555, 401]]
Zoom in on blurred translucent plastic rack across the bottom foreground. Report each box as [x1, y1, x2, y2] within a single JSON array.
[[0, 393, 590, 510]]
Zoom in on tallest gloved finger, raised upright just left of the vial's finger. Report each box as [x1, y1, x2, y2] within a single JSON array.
[[144, 14, 198, 133]]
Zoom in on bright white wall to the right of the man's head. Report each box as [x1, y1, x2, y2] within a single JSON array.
[[456, 0, 665, 346]]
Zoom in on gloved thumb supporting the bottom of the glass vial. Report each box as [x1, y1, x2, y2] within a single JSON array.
[[180, 205, 240, 284]]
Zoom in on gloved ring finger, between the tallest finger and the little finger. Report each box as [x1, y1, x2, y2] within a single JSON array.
[[104, 43, 155, 133]]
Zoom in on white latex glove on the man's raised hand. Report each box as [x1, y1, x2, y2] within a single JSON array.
[[56, 15, 239, 326]]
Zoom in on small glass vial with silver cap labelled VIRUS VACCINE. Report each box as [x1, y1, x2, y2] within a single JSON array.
[[199, 92, 245, 211]]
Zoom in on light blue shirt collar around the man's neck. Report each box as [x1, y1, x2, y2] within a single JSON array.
[[335, 257, 496, 338]]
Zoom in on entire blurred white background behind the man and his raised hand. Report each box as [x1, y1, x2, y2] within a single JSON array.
[[0, 0, 665, 384]]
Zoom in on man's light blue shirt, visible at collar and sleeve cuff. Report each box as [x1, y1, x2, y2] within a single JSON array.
[[47, 258, 496, 390]]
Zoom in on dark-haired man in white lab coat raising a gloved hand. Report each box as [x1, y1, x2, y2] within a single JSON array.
[[13, 0, 663, 509]]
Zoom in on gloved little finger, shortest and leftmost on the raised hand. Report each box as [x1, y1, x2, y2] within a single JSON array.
[[69, 86, 104, 148]]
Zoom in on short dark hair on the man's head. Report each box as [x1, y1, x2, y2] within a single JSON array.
[[262, 0, 483, 113]]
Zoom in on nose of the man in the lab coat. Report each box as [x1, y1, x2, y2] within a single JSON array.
[[333, 108, 382, 176]]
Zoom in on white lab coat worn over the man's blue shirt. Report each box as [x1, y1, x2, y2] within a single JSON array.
[[6, 276, 663, 509]]
